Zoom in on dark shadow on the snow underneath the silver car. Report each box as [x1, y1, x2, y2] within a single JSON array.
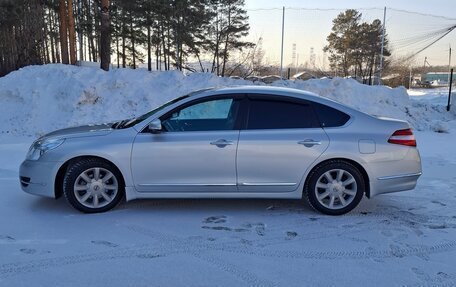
[[28, 196, 405, 218]]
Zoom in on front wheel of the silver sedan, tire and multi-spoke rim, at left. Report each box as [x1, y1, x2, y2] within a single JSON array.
[[63, 158, 125, 213]]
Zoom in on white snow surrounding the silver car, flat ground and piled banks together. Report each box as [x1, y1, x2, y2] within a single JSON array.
[[0, 66, 456, 286]]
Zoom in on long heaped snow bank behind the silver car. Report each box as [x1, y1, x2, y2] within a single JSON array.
[[0, 65, 456, 136]]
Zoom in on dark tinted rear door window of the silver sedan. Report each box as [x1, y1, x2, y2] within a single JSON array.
[[247, 100, 320, 130]]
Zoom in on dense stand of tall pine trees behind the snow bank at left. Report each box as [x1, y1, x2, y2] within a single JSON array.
[[0, 0, 255, 76]]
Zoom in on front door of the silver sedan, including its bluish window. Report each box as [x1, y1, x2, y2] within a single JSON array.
[[131, 96, 239, 192]]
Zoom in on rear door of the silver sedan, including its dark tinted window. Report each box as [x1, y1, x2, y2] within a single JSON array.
[[237, 95, 329, 192]]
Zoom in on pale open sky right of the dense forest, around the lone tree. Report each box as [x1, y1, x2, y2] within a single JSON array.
[[245, 0, 456, 68]]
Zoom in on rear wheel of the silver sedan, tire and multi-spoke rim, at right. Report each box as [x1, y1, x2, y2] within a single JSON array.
[[304, 160, 365, 215]]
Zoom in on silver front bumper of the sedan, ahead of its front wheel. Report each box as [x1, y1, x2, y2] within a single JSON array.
[[19, 160, 62, 198]]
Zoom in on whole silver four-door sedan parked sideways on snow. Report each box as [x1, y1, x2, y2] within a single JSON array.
[[20, 86, 421, 215]]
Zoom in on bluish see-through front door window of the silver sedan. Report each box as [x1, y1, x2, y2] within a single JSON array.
[[162, 99, 239, 132]]
